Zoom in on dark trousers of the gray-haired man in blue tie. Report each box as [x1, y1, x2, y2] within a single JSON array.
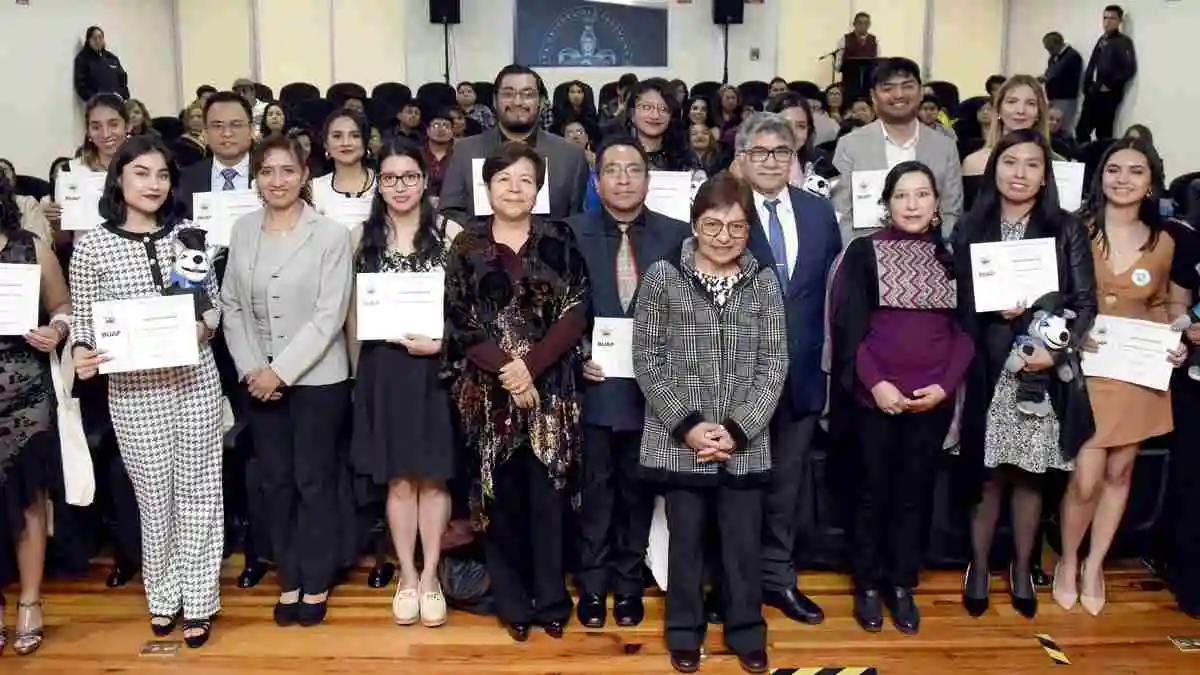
[[762, 414, 817, 592]]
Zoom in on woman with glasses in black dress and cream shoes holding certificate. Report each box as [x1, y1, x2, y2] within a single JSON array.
[[346, 141, 462, 627]]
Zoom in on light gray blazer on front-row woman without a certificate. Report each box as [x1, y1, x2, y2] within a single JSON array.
[[221, 204, 353, 386]]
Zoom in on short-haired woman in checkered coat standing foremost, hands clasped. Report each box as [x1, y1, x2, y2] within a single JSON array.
[[634, 173, 787, 673]]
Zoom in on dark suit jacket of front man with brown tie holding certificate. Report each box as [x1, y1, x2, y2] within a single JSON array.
[[566, 210, 691, 431]]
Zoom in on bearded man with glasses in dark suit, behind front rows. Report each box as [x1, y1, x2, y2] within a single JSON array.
[[438, 65, 590, 222]]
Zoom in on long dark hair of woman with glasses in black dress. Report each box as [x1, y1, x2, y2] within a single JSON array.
[[354, 138, 445, 271]]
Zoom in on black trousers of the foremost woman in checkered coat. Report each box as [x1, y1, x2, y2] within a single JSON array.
[[666, 486, 767, 653]]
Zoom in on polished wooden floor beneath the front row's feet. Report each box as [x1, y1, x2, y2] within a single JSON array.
[[0, 557, 1200, 675]]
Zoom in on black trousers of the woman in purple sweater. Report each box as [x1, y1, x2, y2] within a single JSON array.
[[852, 402, 954, 590]]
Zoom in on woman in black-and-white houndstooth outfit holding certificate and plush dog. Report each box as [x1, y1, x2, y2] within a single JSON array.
[[71, 136, 224, 647]]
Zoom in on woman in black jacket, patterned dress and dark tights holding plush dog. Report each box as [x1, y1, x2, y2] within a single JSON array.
[[954, 129, 1096, 617]]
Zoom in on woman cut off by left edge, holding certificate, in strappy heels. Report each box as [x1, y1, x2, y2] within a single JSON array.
[[0, 175, 71, 656]]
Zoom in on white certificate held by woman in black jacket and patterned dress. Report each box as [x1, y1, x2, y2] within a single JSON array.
[[971, 237, 1058, 312]]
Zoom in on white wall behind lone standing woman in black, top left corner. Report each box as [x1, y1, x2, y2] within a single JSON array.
[[0, 0, 180, 177]]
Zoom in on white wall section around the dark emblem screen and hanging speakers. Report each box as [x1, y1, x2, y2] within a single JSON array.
[[397, 0, 777, 90]]
